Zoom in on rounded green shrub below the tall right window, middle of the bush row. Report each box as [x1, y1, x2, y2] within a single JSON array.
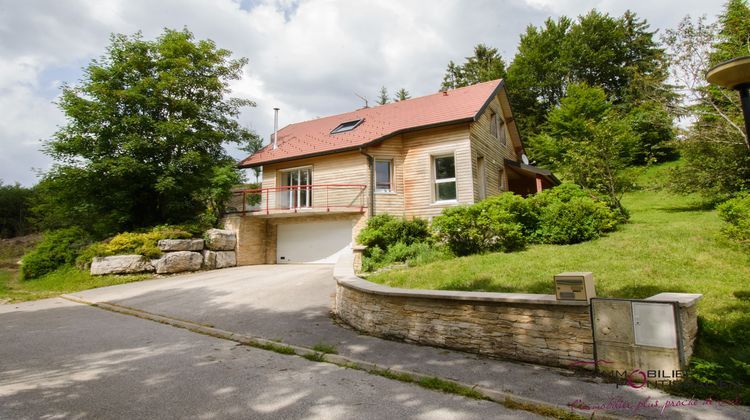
[[432, 200, 526, 256]]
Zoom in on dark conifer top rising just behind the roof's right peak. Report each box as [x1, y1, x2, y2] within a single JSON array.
[[441, 44, 505, 90]]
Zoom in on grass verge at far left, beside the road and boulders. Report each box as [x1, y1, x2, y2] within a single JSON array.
[[0, 238, 152, 303]]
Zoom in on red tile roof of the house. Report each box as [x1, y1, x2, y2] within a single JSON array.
[[239, 79, 502, 168]]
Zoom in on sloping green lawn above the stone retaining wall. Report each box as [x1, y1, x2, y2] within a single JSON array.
[[368, 164, 750, 398]]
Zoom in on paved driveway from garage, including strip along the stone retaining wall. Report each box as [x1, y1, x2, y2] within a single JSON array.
[[63, 265, 750, 419]]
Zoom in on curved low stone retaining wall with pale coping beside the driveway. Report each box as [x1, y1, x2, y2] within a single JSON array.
[[334, 253, 594, 367]]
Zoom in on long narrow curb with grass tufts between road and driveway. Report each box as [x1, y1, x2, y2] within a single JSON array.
[[60, 294, 630, 419]]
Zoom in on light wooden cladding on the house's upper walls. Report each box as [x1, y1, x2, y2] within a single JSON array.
[[262, 90, 521, 223]]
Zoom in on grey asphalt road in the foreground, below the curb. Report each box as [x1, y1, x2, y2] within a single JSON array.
[[0, 299, 532, 419]]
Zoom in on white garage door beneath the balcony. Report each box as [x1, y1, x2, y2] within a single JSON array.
[[276, 220, 352, 264]]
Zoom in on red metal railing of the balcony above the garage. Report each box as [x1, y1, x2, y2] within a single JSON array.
[[226, 184, 367, 214]]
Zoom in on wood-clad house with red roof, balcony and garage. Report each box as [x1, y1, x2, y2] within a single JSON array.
[[225, 80, 558, 265]]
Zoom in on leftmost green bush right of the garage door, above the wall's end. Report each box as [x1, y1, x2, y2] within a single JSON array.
[[357, 214, 430, 250]]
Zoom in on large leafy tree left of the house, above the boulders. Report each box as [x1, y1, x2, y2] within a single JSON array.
[[37, 29, 254, 235]]
